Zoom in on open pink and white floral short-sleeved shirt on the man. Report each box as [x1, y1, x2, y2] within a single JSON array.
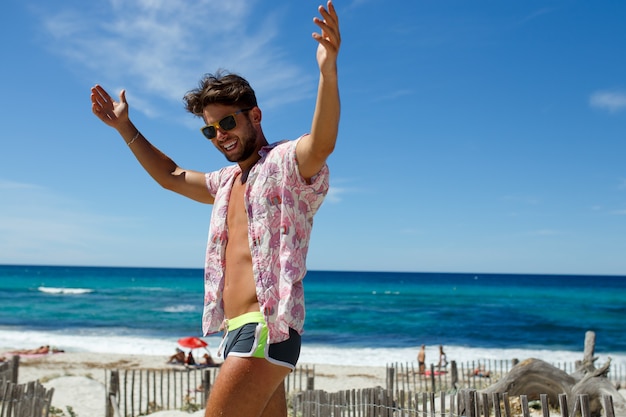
[[202, 139, 329, 343]]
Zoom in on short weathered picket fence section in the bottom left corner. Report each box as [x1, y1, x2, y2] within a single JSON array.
[[0, 381, 54, 417]]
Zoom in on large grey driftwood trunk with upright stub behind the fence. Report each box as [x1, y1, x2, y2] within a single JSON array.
[[480, 332, 626, 417]]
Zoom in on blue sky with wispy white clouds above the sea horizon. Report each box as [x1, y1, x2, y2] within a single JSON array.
[[0, 0, 626, 275]]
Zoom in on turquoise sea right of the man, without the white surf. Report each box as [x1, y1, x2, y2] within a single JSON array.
[[306, 272, 626, 352]]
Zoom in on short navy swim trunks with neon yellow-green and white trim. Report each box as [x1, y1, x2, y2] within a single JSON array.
[[222, 312, 301, 371]]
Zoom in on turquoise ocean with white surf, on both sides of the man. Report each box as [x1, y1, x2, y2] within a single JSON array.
[[0, 265, 626, 366]]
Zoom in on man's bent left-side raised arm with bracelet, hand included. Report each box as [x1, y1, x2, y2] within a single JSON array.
[[91, 85, 213, 204]]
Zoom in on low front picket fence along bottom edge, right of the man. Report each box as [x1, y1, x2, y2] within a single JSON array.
[[289, 387, 615, 417]]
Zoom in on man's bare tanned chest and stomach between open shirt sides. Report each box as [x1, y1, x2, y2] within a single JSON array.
[[224, 172, 259, 319]]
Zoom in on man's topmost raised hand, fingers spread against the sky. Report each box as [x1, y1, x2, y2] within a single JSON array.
[[313, 0, 341, 74]]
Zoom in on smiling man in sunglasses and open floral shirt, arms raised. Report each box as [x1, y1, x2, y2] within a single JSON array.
[[91, 1, 341, 417]]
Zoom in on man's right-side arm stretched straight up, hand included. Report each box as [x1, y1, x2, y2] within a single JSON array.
[[296, 1, 341, 178]]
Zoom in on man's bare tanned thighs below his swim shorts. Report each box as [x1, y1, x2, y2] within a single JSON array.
[[204, 356, 290, 417]]
